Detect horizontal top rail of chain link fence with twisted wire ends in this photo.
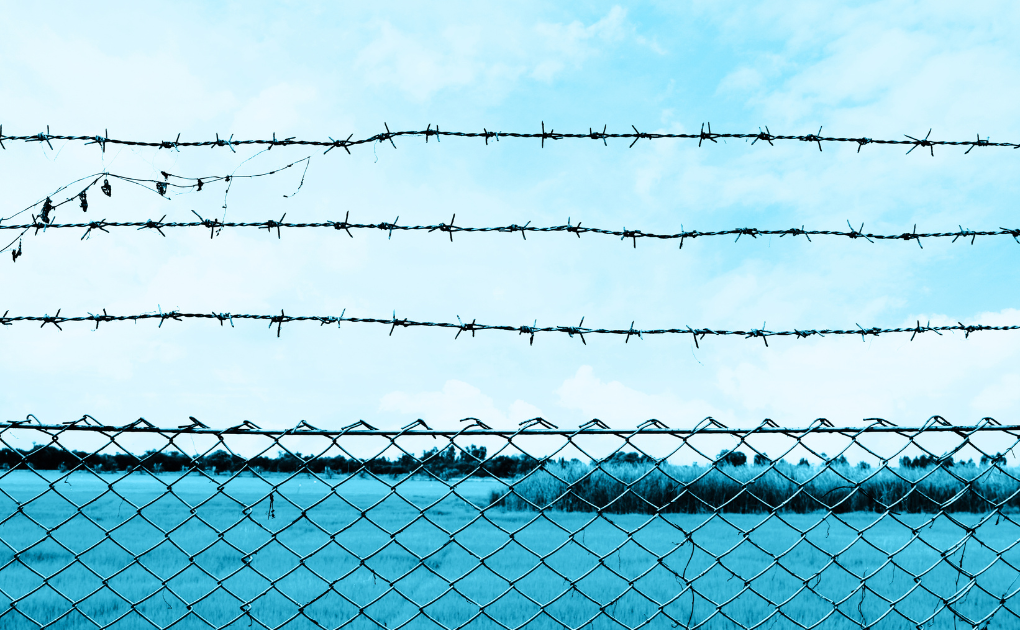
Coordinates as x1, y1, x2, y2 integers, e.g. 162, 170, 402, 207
0, 416, 1020, 438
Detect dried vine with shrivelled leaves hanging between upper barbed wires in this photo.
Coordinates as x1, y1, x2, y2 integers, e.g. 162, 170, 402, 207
0, 158, 311, 255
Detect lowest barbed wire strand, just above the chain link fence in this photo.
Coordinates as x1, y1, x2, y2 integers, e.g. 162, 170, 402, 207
0, 309, 1020, 340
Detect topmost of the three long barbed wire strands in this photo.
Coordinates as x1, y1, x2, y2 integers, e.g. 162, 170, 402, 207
0, 121, 1007, 156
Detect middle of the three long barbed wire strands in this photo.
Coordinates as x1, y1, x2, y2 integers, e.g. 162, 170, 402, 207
0, 210, 1020, 249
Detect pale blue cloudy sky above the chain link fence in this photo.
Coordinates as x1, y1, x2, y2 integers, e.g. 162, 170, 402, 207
0, 1, 1020, 436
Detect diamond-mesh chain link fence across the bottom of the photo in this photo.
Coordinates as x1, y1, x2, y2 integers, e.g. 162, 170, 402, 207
0, 416, 1020, 630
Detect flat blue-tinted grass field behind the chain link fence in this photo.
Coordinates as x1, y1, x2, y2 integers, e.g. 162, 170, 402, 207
0, 471, 1020, 630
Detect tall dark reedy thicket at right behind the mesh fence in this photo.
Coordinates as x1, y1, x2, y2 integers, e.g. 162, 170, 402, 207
490, 457, 1020, 514
